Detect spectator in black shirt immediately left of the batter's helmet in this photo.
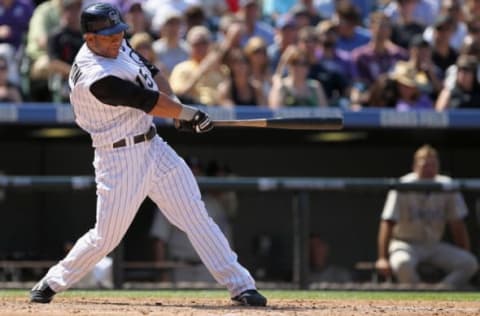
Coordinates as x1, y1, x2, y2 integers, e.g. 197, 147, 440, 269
47, 0, 84, 103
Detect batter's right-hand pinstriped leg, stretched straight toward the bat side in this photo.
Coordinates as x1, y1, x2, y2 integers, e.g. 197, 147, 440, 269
149, 140, 264, 304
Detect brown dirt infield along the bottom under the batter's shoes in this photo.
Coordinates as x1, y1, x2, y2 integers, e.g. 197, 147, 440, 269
0, 297, 480, 316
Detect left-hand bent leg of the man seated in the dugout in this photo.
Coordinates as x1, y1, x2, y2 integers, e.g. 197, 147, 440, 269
389, 240, 420, 284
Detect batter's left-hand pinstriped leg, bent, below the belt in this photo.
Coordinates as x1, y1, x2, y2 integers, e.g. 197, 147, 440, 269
32, 146, 148, 299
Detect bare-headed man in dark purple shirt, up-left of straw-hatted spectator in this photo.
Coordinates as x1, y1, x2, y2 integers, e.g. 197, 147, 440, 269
350, 11, 408, 105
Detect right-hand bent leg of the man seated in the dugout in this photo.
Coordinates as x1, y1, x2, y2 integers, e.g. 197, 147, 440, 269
429, 242, 478, 287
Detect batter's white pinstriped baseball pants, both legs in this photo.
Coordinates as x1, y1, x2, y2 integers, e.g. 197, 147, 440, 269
44, 136, 255, 296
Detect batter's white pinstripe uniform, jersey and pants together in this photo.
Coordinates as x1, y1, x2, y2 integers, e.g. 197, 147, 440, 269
40, 40, 255, 297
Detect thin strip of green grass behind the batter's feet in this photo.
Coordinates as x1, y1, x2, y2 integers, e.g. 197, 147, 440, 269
0, 290, 480, 302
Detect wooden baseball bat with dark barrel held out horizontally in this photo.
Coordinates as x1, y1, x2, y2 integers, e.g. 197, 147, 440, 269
213, 116, 343, 130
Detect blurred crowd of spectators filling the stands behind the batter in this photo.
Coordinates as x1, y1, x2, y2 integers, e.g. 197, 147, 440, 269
0, 0, 480, 111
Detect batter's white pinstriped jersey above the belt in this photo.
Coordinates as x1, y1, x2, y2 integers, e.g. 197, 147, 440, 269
69, 40, 158, 147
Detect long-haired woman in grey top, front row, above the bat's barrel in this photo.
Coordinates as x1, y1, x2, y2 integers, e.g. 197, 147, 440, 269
268, 46, 328, 109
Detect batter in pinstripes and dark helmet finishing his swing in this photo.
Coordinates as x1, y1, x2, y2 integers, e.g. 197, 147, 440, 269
31, 3, 267, 306
